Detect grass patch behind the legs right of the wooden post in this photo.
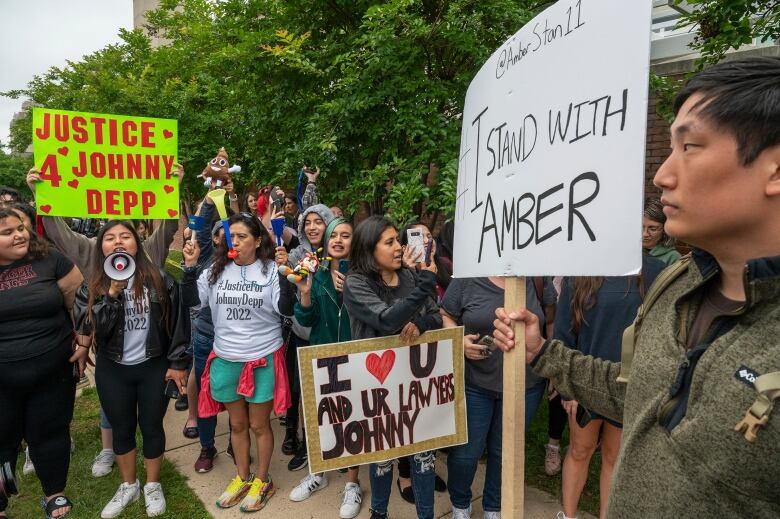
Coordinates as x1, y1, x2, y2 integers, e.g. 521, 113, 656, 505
525, 398, 601, 517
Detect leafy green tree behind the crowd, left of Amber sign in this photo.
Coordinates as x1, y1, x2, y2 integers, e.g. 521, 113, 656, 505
7, 0, 548, 223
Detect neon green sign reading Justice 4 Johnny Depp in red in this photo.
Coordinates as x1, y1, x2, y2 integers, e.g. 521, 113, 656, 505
32, 108, 179, 219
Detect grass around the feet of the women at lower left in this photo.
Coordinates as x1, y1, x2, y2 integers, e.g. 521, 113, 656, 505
7, 389, 211, 519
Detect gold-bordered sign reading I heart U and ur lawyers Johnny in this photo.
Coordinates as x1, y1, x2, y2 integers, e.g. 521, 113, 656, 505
298, 328, 468, 474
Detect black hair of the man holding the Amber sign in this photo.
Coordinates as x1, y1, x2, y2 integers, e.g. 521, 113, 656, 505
674, 57, 780, 166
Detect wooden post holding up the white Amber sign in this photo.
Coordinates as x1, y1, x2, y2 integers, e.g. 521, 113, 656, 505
501, 277, 525, 517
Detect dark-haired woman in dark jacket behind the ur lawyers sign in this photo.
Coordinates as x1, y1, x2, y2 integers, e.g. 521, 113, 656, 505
344, 216, 442, 519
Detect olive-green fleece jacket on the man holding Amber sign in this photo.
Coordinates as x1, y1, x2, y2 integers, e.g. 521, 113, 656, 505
533, 251, 780, 519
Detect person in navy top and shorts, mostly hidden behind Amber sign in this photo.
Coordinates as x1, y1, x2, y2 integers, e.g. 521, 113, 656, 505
553, 254, 664, 519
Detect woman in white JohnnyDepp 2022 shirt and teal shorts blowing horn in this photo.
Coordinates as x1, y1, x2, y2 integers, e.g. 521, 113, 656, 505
184, 213, 293, 512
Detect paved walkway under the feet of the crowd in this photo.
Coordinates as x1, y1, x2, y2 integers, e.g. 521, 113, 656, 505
165, 404, 592, 519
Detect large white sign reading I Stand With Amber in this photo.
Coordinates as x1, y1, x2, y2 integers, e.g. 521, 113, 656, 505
453, 0, 651, 277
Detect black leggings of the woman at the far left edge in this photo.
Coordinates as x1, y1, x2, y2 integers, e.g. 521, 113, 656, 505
0, 339, 76, 511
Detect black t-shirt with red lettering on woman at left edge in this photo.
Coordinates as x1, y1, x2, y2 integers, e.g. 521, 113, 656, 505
0, 250, 73, 362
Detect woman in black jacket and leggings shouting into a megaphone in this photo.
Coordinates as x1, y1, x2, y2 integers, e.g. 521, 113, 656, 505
76, 220, 190, 518
